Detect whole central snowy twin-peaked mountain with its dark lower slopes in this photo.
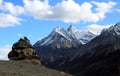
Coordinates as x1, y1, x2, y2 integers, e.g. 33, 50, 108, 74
34, 25, 106, 65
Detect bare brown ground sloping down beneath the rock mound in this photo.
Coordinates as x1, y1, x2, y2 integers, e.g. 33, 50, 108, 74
0, 60, 72, 76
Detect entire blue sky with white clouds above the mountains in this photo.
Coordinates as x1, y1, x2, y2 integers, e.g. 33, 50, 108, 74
0, 0, 120, 47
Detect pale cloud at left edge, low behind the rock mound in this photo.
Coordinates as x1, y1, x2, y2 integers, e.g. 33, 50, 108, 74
0, 45, 11, 60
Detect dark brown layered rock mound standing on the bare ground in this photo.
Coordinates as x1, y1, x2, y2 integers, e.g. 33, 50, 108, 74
8, 37, 38, 60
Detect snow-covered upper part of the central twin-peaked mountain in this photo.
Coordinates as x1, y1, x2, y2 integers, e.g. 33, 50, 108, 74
38, 25, 100, 44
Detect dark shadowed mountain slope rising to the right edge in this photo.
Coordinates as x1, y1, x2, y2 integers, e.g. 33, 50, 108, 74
60, 23, 120, 76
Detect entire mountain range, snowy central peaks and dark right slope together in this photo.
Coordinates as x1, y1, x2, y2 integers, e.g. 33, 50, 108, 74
34, 22, 120, 76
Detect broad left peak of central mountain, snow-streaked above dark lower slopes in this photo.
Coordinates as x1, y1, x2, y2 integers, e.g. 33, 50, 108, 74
36, 27, 80, 48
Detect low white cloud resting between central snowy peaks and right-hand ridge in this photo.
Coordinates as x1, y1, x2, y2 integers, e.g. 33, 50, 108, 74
86, 24, 111, 35
